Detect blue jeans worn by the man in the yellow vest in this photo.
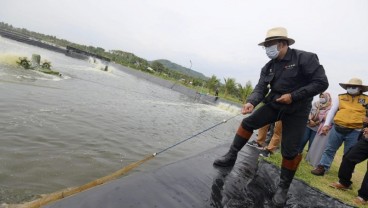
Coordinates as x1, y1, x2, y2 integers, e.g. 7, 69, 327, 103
319, 126, 360, 171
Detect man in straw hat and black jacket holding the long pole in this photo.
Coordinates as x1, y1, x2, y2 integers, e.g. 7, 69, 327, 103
214, 27, 328, 206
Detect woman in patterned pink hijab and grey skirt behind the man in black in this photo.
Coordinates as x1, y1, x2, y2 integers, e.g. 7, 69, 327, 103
301, 92, 332, 167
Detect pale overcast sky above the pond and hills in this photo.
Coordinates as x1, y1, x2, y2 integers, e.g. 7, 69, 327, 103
0, 0, 368, 96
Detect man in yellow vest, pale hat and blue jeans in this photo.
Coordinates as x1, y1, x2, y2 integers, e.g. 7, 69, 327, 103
311, 78, 368, 176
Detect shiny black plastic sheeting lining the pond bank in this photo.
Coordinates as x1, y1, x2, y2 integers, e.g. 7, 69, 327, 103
46, 144, 351, 208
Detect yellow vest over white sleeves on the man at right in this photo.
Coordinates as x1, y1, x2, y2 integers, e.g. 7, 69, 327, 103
334, 94, 368, 129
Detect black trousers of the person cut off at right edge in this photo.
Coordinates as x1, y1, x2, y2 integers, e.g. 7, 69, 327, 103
339, 139, 368, 200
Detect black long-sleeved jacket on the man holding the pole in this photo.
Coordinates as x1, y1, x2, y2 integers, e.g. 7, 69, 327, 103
247, 48, 328, 106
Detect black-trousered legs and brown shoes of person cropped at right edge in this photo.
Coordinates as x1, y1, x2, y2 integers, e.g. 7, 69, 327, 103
330, 126, 368, 205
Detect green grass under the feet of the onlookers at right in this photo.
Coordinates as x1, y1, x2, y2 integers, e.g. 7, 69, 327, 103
265, 146, 368, 208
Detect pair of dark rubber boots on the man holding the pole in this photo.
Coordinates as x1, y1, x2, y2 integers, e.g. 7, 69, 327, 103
213, 136, 296, 207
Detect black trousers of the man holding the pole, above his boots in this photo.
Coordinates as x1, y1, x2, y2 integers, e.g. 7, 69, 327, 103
241, 102, 311, 160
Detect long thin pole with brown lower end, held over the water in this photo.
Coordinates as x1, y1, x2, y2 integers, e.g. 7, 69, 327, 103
11, 113, 241, 208
